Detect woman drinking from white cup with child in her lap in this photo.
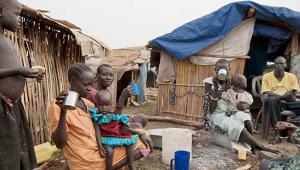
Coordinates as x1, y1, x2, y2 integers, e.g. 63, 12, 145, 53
204, 59, 274, 152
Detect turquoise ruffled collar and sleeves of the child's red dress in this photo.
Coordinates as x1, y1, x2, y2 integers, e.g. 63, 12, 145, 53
88, 108, 129, 125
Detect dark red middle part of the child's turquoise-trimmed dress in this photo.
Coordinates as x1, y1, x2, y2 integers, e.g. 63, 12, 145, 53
99, 120, 132, 138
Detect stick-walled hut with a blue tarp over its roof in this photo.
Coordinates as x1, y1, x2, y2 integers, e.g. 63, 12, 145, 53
147, 1, 300, 119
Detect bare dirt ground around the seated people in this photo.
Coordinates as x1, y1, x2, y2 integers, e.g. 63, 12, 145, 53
45, 101, 297, 170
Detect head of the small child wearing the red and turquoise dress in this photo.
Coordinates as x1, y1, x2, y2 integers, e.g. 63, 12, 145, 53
95, 90, 111, 114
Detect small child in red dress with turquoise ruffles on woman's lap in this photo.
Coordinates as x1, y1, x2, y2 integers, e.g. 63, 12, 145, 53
89, 90, 143, 170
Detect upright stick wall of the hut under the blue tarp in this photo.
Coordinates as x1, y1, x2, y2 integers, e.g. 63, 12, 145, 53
158, 52, 246, 120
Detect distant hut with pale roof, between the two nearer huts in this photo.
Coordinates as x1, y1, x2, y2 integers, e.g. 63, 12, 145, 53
99, 46, 150, 105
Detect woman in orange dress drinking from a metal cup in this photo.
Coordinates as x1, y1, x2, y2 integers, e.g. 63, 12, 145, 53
48, 64, 153, 170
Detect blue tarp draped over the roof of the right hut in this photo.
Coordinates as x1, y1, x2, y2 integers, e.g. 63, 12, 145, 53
149, 1, 300, 60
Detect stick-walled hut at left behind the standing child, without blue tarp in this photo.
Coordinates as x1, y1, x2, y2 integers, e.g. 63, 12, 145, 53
5, 5, 108, 144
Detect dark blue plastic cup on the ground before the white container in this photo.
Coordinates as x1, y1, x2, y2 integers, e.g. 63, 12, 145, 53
170, 151, 190, 170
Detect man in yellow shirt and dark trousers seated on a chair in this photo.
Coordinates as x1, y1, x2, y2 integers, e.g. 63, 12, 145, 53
261, 56, 300, 127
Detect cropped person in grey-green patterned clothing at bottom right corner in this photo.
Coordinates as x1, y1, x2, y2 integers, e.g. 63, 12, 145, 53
259, 128, 300, 170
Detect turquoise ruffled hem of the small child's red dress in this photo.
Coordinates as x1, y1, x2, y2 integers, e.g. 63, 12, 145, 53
101, 135, 139, 147
